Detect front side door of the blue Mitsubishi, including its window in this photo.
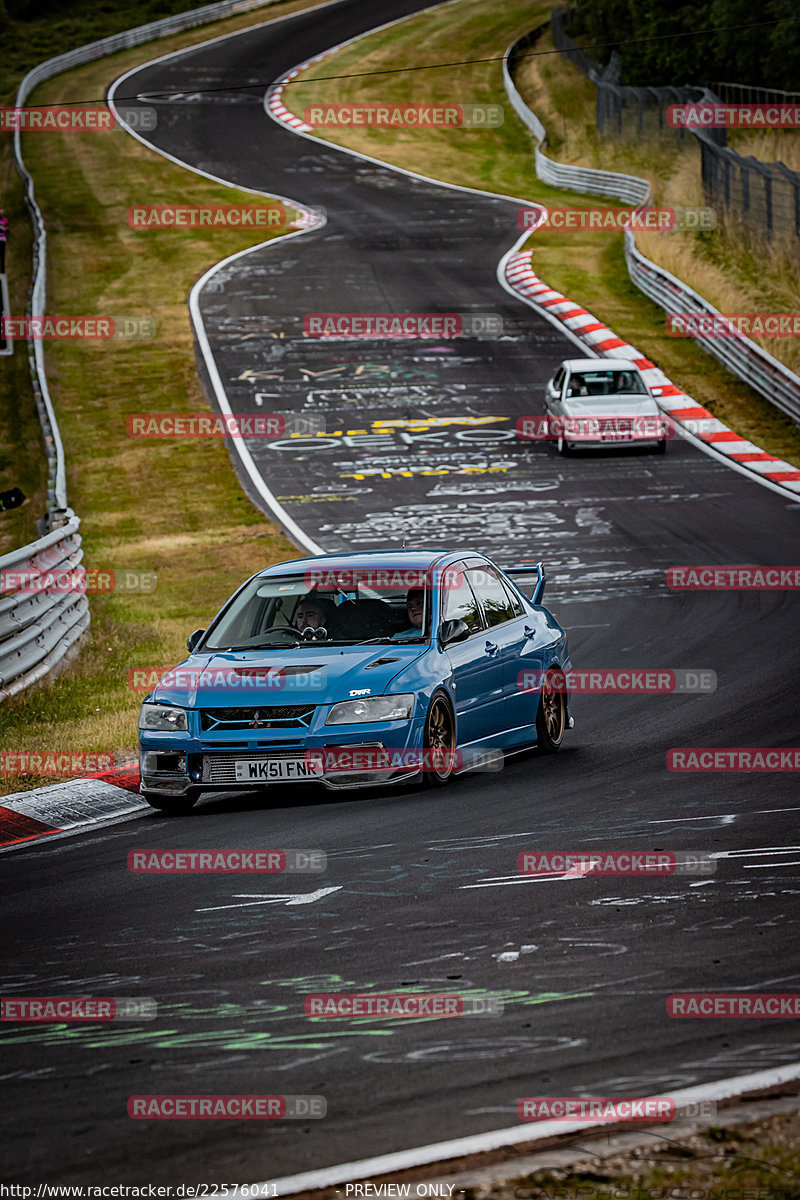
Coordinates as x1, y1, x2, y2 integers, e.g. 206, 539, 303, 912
441, 563, 497, 746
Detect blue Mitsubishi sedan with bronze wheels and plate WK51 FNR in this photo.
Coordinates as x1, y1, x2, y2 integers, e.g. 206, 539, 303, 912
139, 550, 572, 812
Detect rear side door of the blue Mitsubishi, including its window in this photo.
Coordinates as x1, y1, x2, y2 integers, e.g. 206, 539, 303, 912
467, 563, 527, 733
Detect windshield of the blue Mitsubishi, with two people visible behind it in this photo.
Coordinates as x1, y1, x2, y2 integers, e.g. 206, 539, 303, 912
200, 566, 431, 650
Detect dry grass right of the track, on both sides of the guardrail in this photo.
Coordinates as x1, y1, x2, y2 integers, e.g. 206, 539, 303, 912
283, 0, 800, 467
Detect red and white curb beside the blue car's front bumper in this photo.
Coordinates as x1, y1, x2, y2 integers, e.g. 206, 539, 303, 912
0, 766, 149, 850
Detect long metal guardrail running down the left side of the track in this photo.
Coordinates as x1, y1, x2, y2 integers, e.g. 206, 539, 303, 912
0, 0, 284, 701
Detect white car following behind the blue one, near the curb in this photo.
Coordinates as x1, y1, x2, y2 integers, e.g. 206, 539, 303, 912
545, 359, 670, 454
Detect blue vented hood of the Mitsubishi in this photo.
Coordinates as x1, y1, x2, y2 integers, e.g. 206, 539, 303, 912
149, 644, 428, 708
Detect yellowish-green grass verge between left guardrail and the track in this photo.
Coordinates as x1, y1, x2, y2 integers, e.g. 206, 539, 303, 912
0, 2, 326, 793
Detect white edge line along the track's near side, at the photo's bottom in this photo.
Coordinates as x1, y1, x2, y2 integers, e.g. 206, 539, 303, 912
248, 1062, 800, 1195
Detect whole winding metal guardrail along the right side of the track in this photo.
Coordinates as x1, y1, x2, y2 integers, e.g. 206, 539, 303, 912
503, 34, 800, 424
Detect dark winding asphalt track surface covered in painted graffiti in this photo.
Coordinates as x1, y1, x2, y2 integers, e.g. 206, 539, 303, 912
0, 4, 800, 1183
